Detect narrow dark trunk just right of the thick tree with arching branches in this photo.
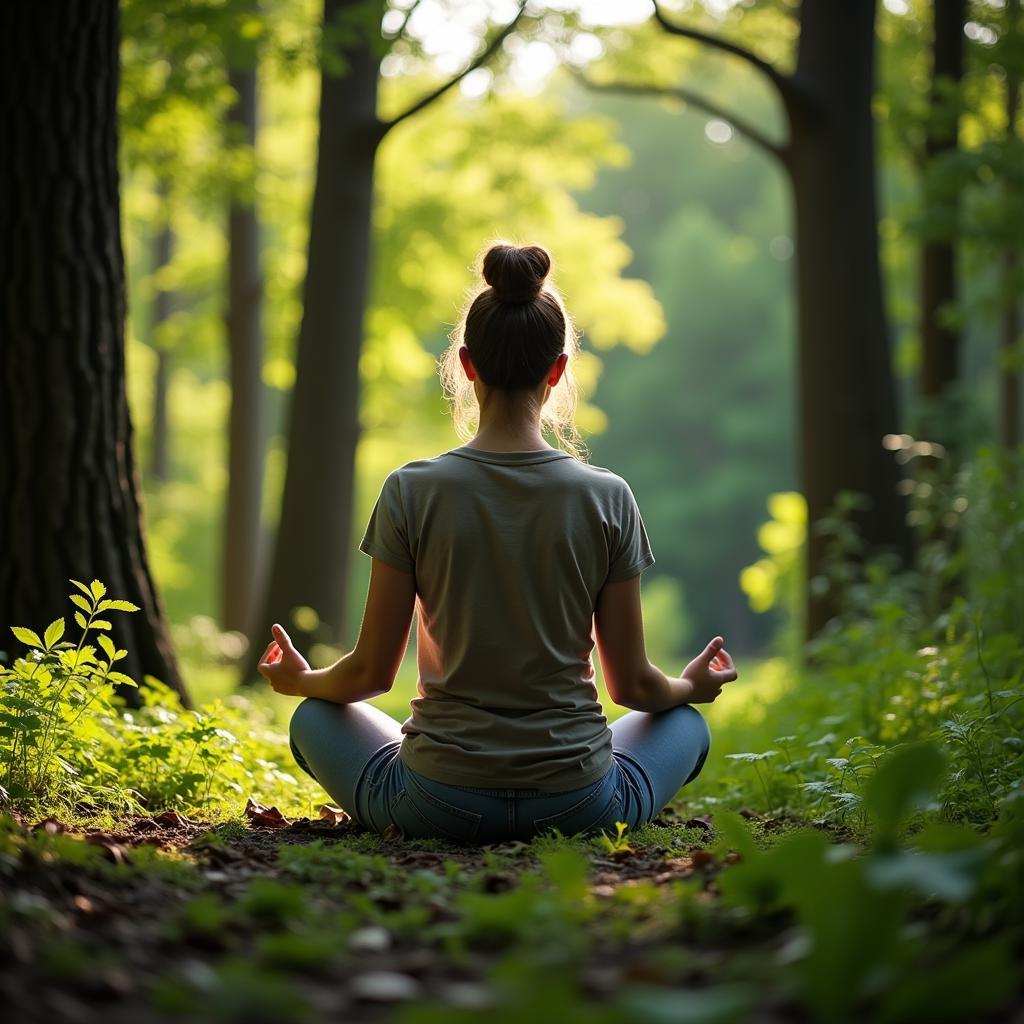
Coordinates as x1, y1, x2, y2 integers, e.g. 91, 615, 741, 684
921, 0, 967, 415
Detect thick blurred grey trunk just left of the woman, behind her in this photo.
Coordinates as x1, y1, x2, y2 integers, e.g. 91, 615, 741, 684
245, 0, 382, 677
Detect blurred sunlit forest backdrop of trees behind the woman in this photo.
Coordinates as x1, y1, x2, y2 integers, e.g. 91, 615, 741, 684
8, 0, 1022, 700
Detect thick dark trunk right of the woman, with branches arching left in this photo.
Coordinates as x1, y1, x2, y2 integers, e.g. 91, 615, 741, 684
787, 0, 911, 636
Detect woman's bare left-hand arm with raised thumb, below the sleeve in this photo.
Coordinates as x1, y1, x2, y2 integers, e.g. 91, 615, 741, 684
259, 558, 416, 703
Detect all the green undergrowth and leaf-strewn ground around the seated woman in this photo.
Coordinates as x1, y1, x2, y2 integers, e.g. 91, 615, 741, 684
0, 459, 1024, 1024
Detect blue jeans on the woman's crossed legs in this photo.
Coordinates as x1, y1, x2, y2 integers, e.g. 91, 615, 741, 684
291, 699, 711, 844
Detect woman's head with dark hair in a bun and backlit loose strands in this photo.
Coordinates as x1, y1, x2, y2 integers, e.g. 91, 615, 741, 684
440, 243, 586, 457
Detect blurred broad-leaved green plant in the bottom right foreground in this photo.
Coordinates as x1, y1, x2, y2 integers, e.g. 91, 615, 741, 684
716, 798, 1016, 1022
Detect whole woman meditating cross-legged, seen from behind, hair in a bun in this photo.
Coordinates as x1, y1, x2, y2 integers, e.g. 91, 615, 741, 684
259, 245, 736, 844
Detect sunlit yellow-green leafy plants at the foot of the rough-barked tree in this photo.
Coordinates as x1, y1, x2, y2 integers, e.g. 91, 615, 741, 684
0, 580, 315, 813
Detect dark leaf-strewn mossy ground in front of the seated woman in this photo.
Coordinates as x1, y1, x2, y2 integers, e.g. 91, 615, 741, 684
0, 806, 803, 1024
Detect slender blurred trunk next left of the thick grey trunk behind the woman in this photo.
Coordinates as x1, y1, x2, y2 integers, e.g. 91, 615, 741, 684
221, 68, 265, 632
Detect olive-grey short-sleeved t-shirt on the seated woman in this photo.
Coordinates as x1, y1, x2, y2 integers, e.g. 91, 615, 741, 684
359, 446, 654, 793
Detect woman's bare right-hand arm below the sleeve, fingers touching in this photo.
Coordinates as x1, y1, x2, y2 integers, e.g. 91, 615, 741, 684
594, 574, 736, 712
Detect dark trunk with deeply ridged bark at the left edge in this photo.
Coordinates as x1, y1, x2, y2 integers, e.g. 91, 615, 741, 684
0, 0, 183, 695
